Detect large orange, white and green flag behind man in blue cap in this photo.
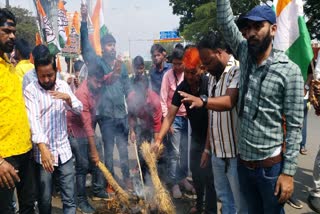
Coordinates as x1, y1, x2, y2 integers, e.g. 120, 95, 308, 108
273, 0, 313, 80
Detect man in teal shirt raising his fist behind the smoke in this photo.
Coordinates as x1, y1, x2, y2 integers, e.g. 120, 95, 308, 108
81, 5, 132, 189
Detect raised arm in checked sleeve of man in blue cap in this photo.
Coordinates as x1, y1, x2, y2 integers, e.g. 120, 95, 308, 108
217, 0, 246, 59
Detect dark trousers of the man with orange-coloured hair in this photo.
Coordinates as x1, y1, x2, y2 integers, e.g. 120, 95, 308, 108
190, 138, 217, 214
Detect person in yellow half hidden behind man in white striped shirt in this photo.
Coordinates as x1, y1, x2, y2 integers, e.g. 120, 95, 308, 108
14, 39, 34, 82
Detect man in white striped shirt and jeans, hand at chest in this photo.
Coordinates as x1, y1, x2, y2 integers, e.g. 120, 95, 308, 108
24, 45, 82, 214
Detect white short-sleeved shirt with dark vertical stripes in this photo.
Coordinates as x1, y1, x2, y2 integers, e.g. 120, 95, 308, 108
208, 56, 240, 158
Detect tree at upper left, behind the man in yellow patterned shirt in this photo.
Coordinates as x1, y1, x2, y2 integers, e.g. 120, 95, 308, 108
9, 7, 38, 47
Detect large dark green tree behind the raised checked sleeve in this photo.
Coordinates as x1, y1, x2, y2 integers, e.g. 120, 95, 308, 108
170, 0, 267, 41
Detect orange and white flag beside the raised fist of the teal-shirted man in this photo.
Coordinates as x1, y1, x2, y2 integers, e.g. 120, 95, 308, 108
90, 0, 108, 56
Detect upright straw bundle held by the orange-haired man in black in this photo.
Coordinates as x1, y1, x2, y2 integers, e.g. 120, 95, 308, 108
140, 142, 176, 214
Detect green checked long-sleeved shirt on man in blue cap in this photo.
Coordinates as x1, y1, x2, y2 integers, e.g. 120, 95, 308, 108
217, 0, 304, 175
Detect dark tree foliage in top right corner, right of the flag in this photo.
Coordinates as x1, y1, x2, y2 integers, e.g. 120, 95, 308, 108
304, 0, 320, 40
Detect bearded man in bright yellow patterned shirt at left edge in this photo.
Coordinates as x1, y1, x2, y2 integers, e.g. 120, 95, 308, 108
0, 9, 35, 214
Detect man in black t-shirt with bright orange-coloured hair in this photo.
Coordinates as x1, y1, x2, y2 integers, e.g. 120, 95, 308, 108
153, 48, 217, 213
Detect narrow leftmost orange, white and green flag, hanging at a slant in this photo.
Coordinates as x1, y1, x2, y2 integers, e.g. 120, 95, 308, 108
36, 0, 60, 55
